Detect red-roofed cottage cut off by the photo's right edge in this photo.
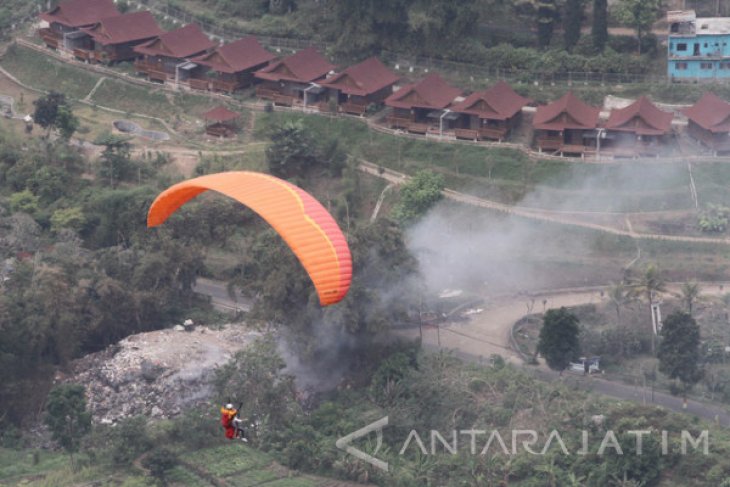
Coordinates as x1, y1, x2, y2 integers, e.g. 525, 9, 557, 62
682, 93, 730, 155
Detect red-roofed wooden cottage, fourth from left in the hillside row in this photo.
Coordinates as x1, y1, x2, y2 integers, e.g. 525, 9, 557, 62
190, 36, 276, 93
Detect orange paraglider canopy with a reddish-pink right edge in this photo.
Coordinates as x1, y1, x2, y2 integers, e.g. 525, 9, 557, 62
147, 171, 352, 306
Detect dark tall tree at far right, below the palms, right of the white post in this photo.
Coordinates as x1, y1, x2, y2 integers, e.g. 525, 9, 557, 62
657, 311, 704, 396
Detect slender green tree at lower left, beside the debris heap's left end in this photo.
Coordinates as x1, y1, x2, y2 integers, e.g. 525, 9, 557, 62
44, 384, 91, 468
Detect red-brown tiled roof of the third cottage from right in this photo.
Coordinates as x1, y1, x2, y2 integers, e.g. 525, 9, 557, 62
532, 92, 601, 131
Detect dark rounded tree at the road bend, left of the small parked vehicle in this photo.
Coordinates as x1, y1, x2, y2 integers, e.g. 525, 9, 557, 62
537, 307, 580, 371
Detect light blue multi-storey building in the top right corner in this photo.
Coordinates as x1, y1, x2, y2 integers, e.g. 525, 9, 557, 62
667, 10, 730, 81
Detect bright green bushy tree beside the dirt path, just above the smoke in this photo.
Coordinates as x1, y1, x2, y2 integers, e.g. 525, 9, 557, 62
393, 170, 445, 224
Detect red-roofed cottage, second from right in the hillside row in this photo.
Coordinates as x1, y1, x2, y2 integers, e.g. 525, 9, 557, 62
598, 96, 674, 157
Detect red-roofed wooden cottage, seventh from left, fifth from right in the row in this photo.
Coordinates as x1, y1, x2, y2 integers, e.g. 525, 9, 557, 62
385, 73, 462, 135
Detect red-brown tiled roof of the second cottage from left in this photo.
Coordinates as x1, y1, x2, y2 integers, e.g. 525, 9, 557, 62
82, 10, 165, 45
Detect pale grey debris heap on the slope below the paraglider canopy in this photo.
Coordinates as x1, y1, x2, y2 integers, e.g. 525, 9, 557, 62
57, 323, 258, 424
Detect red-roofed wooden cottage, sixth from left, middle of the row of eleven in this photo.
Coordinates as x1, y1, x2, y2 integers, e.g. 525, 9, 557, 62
321, 57, 400, 115
